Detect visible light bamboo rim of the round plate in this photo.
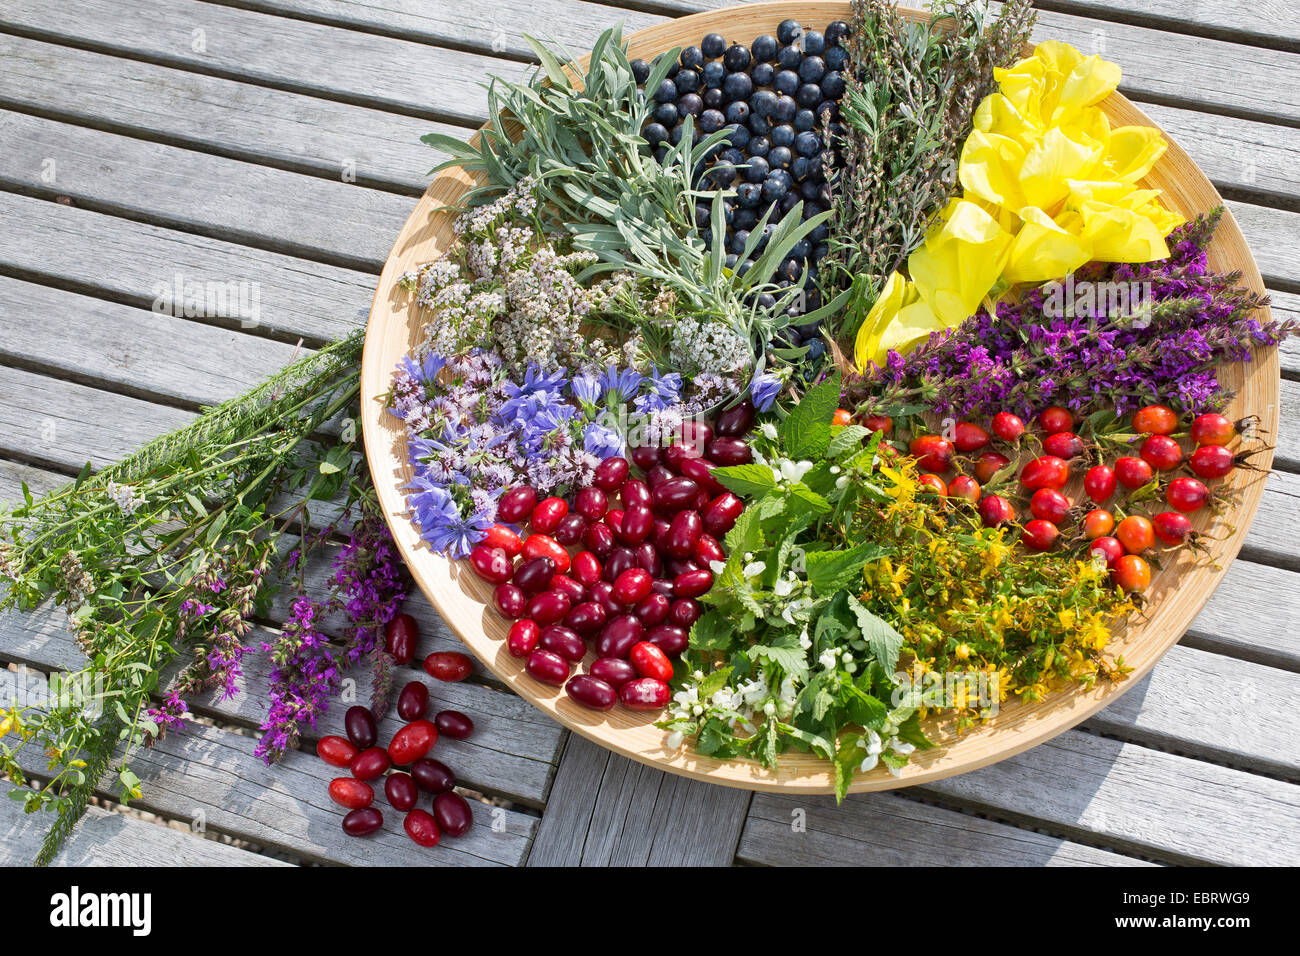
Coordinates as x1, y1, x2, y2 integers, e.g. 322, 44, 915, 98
361, 0, 1279, 793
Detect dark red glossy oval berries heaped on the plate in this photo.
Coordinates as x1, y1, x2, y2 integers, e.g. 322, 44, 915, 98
469, 402, 754, 710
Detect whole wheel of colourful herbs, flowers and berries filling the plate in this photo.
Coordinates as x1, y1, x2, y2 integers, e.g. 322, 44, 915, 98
387, 0, 1294, 796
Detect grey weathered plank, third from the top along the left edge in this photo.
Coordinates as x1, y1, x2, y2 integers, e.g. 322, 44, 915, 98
0, 111, 411, 272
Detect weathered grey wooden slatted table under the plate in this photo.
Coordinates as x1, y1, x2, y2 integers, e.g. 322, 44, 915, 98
0, 0, 1300, 866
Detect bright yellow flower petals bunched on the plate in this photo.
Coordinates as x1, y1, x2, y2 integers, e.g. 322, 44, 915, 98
854, 40, 1183, 368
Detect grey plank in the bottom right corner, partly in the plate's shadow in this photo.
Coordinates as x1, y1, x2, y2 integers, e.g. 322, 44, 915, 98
917, 731, 1300, 866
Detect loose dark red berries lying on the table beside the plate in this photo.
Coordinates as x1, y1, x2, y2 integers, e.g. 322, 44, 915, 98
316, 614, 475, 847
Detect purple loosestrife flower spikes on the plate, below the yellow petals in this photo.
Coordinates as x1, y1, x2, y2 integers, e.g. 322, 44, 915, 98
849, 213, 1296, 418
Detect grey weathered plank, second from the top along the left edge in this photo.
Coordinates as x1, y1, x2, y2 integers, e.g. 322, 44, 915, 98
0, 34, 452, 194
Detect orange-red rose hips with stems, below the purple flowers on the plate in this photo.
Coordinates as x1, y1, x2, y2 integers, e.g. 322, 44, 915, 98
889, 405, 1243, 592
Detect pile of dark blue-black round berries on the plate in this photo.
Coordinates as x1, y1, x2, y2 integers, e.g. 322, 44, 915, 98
632, 20, 849, 358
